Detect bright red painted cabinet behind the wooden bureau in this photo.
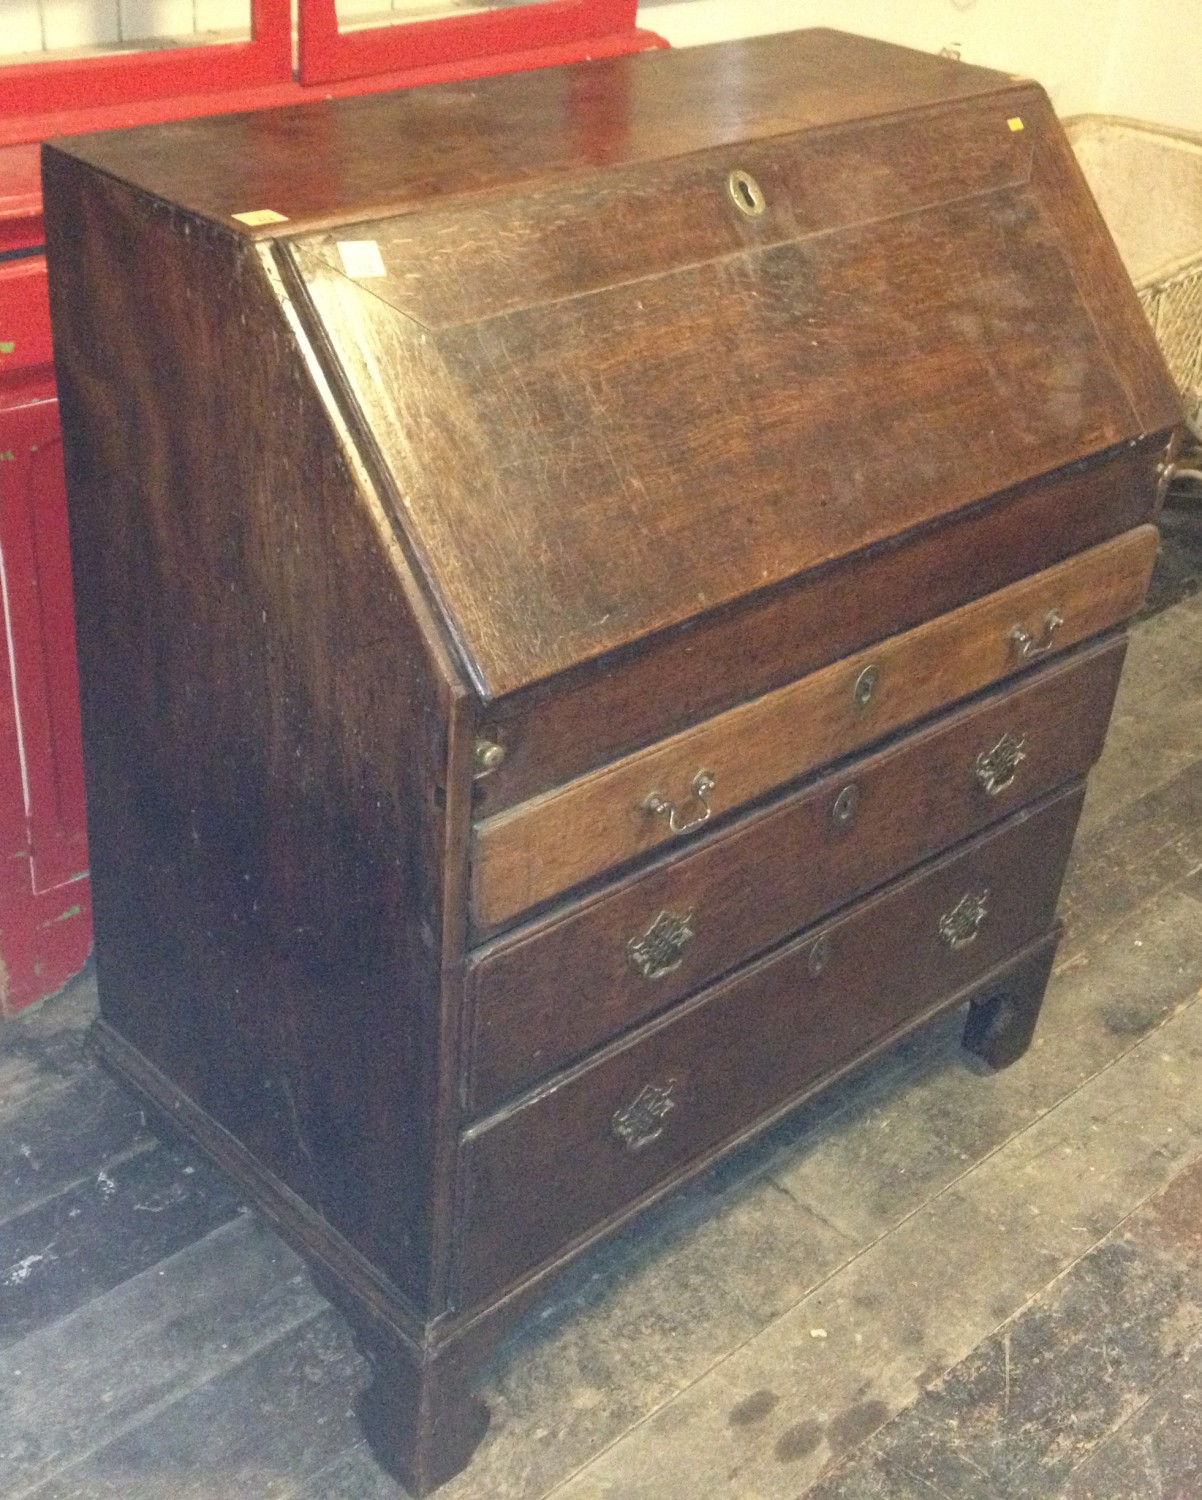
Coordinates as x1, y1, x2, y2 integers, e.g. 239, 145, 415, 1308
0, 0, 665, 1016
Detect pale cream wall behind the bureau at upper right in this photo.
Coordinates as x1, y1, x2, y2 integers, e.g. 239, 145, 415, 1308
639, 0, 1202, 131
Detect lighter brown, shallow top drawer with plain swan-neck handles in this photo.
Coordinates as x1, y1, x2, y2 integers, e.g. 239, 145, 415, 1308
471, 527, 1155, 932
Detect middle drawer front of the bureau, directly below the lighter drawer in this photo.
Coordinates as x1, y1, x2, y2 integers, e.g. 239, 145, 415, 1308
464, 639, 1125, 1113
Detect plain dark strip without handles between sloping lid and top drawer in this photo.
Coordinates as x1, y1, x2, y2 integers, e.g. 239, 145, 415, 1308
476, 432, 1167, 818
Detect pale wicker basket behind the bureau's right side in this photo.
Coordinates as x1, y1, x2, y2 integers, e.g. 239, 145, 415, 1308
1065, 114, 1202, 438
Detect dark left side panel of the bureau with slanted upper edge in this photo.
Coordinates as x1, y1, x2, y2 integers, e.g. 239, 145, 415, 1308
47, 150, 462, 1308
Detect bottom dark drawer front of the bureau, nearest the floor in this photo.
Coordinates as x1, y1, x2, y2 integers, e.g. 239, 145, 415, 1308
458, 785, 1083, 1305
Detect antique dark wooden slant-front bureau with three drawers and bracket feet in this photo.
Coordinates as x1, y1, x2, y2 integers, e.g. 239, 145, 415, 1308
45, 32, 1178, 1493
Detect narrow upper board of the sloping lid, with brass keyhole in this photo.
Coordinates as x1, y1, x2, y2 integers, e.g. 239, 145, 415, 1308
290, 98, 1032, 332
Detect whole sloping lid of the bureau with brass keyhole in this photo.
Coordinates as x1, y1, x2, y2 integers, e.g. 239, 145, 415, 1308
284, 98, 1133, 698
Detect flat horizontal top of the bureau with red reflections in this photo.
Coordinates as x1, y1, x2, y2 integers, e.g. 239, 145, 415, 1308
46, 30, 1029, 239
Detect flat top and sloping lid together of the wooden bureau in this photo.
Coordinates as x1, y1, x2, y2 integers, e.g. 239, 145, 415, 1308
56, 30, 1178, 699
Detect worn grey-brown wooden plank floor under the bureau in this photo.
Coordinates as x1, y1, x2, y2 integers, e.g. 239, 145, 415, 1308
0, 510, 1202, 1500
